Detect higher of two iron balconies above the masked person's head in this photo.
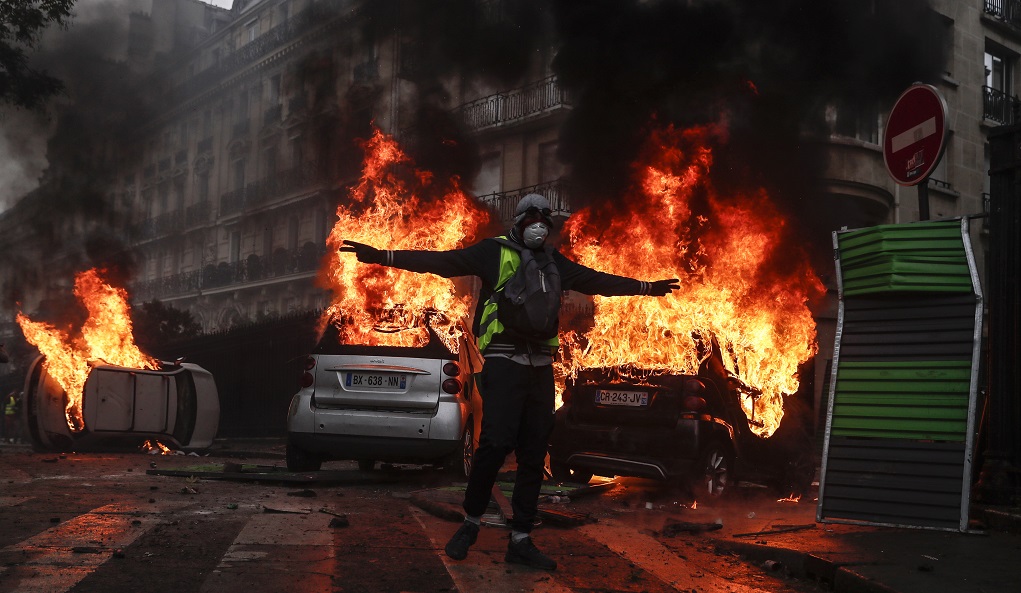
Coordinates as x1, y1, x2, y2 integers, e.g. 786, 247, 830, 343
457, 77, 571, 132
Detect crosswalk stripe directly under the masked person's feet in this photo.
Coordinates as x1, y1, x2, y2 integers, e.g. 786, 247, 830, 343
411, 507, 573, 593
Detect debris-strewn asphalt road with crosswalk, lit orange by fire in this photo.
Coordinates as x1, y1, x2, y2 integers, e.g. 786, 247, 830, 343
0, 447, 825, 593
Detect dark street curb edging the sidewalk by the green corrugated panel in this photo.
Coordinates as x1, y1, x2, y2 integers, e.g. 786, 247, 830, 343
714, 540, 900, 593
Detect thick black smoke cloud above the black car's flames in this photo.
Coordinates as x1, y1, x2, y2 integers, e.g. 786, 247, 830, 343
553, 0, 946, 260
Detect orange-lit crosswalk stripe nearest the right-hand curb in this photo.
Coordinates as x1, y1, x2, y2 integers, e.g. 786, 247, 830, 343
579, 518, 770, 593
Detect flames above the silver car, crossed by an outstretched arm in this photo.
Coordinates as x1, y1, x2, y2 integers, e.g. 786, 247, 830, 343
321, 130, 489, 352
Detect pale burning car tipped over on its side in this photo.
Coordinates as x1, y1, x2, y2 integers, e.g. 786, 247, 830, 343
22, 356, 220, 451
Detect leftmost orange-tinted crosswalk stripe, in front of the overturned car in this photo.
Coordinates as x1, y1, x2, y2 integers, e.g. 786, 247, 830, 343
0, 504, 179, 593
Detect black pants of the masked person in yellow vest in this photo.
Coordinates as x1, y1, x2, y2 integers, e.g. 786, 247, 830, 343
465, 358, 556, 533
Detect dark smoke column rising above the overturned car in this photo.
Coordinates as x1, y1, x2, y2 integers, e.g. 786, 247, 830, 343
5, 0, 166, 306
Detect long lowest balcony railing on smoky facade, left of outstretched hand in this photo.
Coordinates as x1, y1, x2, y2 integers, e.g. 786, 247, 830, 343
132, 242, 326, 301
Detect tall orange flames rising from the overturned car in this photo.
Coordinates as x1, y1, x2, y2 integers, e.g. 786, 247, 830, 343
16, 268, 159, 432
